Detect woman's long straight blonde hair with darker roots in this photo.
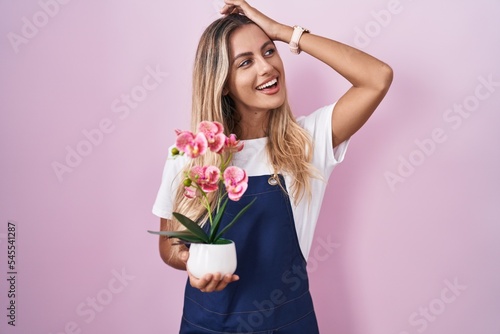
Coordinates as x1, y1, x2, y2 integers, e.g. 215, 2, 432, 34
174, 14, 318, 227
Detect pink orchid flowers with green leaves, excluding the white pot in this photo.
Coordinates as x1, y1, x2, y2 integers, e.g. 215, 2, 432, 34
148, 121, 255, 244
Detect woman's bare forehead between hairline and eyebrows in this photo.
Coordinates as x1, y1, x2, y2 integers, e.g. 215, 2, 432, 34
229, 24, 270, 57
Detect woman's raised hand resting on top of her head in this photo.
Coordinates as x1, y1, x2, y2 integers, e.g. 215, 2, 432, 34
220, 0, 288, 42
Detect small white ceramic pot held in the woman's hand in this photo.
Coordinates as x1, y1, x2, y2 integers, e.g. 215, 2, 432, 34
187, 242, 236, 278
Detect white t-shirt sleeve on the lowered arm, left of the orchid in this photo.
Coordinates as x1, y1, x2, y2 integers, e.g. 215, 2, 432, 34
153, 150, 187, 219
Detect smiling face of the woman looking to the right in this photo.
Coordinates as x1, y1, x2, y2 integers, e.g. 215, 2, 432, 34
226, 24, 286, 117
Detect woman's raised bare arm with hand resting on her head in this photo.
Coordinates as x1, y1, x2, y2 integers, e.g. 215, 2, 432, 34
221, 0, 393, 147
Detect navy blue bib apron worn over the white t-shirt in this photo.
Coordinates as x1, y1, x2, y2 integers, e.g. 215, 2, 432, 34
180, 175, 319, 334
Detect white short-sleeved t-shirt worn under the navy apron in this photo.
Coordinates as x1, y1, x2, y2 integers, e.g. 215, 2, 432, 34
153, 104, 349, 259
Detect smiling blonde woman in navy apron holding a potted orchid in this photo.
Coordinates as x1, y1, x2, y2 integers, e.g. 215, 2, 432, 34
153, 0, 392, 334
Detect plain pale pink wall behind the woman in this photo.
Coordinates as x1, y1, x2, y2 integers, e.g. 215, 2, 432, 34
0, 0, 500, 334
